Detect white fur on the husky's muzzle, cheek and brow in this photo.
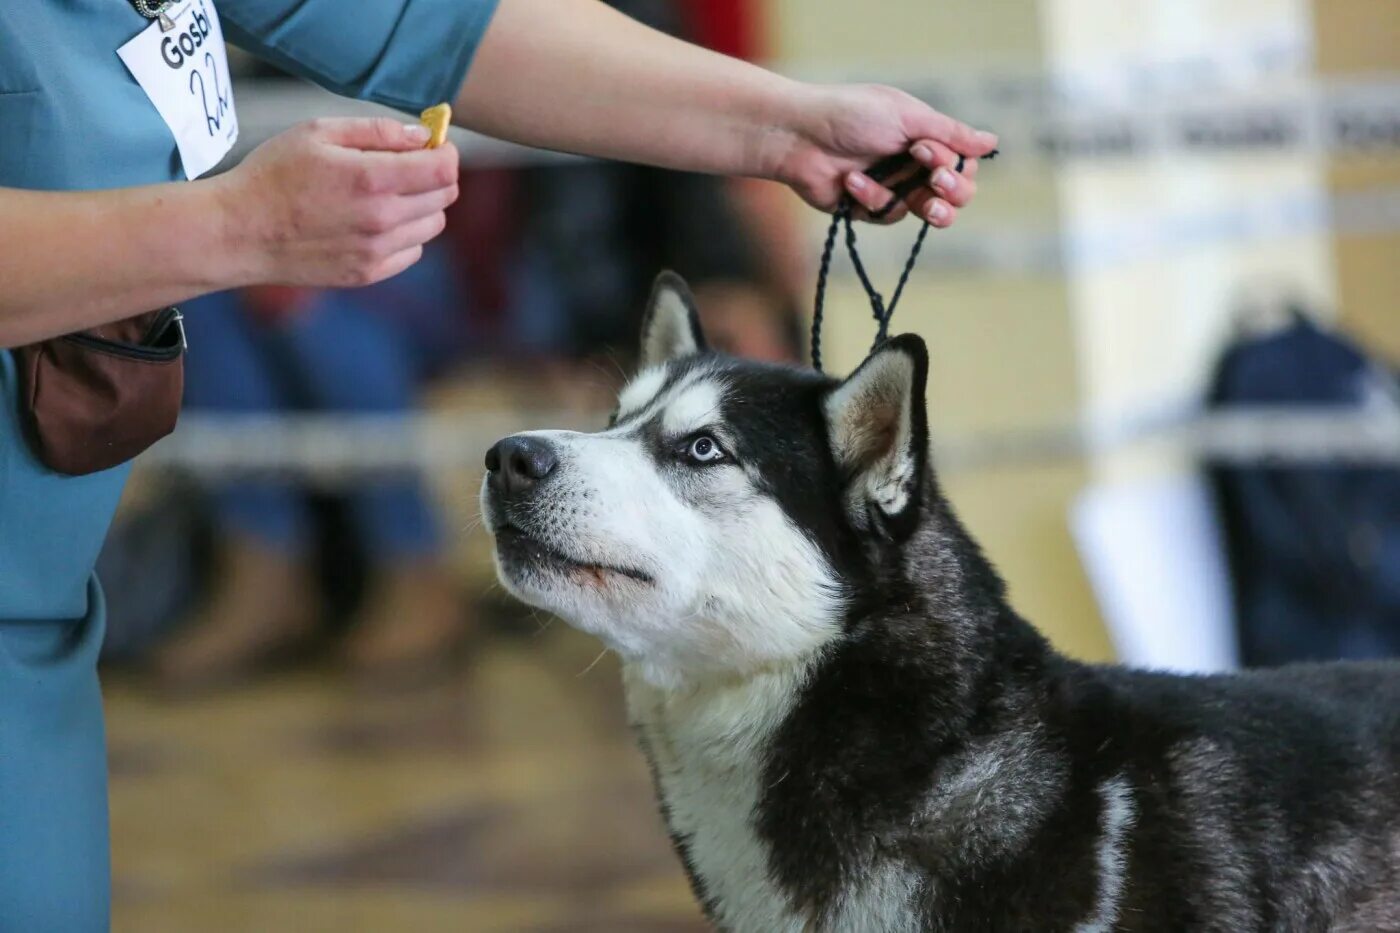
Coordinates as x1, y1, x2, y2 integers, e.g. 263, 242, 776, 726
482, 358, 843, 686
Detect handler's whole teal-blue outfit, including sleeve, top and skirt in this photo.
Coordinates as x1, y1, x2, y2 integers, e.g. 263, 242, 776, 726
0, 0, 494, 933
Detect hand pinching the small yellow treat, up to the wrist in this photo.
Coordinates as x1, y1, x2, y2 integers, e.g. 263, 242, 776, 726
211, 118, 459, 287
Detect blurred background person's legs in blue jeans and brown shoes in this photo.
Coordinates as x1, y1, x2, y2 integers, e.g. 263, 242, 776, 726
155, 248, 469, 686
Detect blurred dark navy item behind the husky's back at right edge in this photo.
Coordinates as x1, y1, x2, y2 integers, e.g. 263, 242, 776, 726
1210, 315, 1400, 665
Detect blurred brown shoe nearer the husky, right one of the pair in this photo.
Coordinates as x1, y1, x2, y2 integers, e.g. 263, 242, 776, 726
342, 559, 472, 686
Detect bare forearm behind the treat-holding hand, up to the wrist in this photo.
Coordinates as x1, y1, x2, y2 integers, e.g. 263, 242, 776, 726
0, 181, 246, 346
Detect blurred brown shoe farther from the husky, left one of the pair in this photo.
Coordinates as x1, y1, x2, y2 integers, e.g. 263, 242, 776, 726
153, 535, 316, 691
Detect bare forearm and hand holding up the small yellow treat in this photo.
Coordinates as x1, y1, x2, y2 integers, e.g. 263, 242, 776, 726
0, 118, 461, 346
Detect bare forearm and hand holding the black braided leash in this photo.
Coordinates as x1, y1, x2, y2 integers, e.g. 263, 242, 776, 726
456, 0, 997, 227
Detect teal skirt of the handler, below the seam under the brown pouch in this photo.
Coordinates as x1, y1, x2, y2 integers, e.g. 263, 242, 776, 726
0, 581, 111, 933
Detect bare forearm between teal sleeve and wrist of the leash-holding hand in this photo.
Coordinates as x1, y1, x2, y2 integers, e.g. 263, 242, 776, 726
455, 0, 804, 177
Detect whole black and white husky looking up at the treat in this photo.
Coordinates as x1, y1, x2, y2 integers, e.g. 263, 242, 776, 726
482, 275, 1400, 933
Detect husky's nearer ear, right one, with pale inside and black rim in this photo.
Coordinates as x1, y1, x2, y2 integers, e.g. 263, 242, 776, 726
825, 333, 928, 537
